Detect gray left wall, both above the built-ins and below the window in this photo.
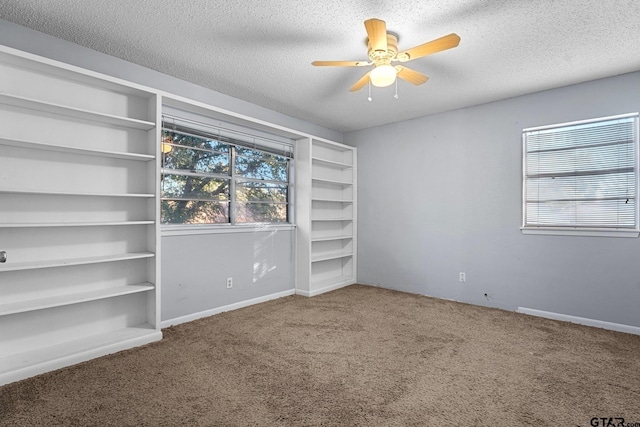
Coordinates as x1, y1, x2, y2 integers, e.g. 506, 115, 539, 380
0, 20, 342, 321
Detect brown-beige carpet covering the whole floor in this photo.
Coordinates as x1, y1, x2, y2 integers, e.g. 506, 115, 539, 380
0, 285, 640, 427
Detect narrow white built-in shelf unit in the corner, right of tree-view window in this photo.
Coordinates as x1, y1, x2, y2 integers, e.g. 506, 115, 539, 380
296, 138, 357, 296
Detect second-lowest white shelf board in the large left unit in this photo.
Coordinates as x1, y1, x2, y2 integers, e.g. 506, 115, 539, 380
0, 283, 154, 316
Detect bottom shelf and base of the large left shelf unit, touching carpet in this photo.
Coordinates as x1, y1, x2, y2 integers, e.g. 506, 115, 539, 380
0, 324, 162, 385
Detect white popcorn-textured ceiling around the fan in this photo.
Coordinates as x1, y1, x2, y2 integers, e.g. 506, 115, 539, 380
0, 0, 640, 132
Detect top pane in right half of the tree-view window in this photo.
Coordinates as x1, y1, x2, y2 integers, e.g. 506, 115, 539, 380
236, 147, 288, 182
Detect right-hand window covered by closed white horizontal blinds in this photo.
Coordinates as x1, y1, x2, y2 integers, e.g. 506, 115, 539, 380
523, 113, 638, 236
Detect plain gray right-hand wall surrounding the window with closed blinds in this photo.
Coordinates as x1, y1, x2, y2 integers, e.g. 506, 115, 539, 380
345, 73, 640, 326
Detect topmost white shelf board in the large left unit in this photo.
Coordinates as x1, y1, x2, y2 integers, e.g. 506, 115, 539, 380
0, 92, 155, 130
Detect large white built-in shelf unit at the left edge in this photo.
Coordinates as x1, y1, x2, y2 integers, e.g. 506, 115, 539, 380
0, 47, 162, 384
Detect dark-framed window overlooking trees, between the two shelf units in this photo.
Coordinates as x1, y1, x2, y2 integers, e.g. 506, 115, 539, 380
161, 118, 292, 224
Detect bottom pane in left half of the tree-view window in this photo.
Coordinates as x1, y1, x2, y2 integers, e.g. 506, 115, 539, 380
162, 199, 229, 224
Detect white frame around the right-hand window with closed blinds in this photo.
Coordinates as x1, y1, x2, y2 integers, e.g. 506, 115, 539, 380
521, 113, 640, 237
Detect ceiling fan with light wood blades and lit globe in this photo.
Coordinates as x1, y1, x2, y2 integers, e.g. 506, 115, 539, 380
311, 18, 460, 92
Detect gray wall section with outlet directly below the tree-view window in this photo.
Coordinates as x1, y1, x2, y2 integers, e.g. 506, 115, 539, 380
161, 229, 295, 321
